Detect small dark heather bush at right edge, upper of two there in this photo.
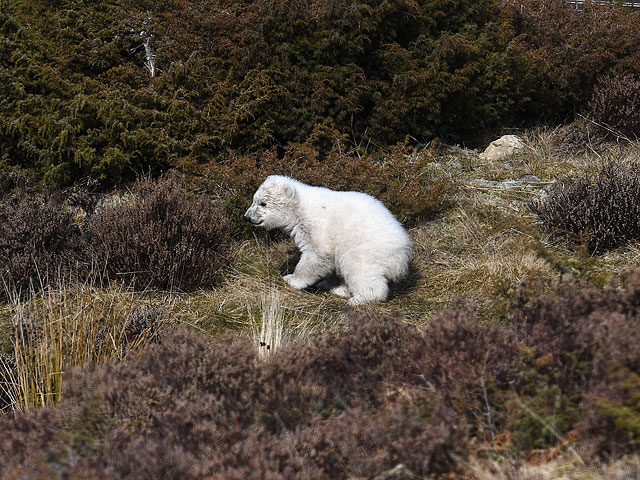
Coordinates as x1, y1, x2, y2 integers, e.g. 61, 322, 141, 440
591, 75, 640, 138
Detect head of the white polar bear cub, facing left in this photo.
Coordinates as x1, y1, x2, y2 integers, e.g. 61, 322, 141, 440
244, 175, 296, 230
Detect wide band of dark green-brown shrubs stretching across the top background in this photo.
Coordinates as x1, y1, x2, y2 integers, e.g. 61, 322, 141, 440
0, 0, 640, 185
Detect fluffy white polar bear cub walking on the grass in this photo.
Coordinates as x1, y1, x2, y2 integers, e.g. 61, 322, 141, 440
244, 175, 412, 305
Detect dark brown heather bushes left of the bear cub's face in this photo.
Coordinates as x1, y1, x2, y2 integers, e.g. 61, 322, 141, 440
0, 178, 230, 296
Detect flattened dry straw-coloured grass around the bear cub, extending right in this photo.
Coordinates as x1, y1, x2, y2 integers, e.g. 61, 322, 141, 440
169, 129, 640, 332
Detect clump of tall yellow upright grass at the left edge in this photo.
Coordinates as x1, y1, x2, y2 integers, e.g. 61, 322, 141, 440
0, 283, 169, 410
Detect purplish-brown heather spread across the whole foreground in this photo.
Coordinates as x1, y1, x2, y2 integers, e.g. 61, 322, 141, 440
0, 272, 640, 479
